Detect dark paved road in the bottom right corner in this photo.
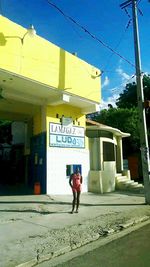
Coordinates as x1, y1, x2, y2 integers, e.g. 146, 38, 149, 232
42, 224, 150, 267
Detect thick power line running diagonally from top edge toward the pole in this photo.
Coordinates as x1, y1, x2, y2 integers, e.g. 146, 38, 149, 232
47, 0, 135, 68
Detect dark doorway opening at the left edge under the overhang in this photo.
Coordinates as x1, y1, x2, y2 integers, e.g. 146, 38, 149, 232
0, 121, 32, 195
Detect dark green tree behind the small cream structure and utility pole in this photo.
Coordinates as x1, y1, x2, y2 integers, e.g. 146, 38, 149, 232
93, 75, 150, 154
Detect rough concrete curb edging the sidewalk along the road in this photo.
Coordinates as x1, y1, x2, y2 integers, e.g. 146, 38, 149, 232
16, 216, 150, 267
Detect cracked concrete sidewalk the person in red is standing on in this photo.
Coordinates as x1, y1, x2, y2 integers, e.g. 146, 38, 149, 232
0, 192, 150, 267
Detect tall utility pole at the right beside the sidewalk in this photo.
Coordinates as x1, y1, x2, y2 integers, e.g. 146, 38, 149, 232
120, 0, 150, 204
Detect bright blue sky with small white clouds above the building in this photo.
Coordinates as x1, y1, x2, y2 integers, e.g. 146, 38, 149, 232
0, 0, 150, 107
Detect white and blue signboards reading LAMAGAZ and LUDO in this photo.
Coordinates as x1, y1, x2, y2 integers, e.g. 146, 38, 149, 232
50, 123, 85, 148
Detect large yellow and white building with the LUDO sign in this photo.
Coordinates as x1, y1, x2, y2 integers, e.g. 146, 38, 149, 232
0, 16, 101, 194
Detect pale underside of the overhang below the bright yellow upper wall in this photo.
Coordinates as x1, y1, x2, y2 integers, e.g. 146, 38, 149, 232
0, 69, 99, 114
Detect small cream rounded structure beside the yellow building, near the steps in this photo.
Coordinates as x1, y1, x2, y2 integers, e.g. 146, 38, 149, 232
86, 119, 130, 193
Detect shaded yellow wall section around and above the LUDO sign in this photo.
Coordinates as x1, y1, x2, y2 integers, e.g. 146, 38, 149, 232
46, 105, 88, 148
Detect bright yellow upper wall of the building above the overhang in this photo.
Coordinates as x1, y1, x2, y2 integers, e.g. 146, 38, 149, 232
0, 16, 101, 103
